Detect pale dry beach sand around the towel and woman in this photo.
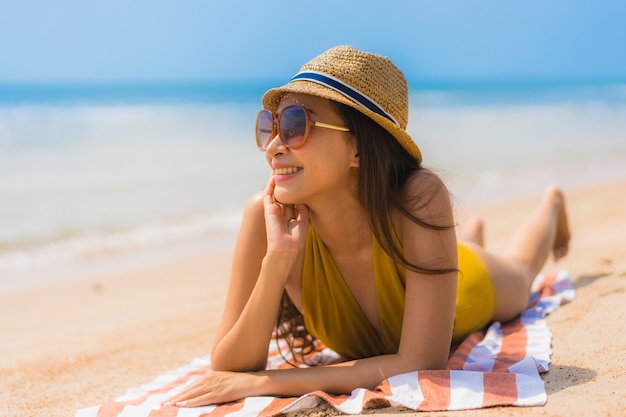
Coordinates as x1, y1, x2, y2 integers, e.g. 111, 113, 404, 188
0, 179, 626, 417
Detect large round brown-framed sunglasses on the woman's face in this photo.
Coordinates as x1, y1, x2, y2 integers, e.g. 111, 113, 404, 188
256, 106, 350, 151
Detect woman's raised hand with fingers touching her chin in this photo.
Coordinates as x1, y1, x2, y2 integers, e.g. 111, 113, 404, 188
263, 176, 309, 254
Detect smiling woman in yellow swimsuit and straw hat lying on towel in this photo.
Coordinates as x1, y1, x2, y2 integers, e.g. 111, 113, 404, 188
163, 46, 570, 407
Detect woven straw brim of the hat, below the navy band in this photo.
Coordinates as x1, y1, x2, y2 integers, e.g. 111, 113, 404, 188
262, 80, 422, 163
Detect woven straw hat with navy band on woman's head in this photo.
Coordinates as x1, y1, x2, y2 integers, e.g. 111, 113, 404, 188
262, 45, 422, 163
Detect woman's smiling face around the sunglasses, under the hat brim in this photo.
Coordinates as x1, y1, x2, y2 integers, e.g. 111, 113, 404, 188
265, 94, 359, 205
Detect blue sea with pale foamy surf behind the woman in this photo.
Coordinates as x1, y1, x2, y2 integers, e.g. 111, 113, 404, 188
0, 81, 626, 292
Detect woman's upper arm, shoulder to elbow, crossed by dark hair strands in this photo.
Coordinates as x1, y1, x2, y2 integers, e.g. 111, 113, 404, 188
396, 171, 458, 370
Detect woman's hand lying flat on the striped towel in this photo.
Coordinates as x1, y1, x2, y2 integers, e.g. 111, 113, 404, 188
163, 369, 259, 407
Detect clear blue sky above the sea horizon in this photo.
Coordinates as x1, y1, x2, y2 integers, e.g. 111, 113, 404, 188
0, 0, 626, 83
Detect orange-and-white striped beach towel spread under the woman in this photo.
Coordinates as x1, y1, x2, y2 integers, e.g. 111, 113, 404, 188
76, 271, 575, 417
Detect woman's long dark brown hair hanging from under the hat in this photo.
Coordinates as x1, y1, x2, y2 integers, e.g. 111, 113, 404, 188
275, 101, 458, 363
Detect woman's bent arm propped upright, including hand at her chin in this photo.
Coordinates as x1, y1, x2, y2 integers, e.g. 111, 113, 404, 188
211, 180, 308, 371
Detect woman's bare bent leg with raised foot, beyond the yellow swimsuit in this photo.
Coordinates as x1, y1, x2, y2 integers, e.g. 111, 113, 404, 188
460, 187, 570, 321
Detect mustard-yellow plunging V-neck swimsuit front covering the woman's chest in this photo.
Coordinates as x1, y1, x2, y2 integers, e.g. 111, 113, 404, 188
302, 225, 406, 359
